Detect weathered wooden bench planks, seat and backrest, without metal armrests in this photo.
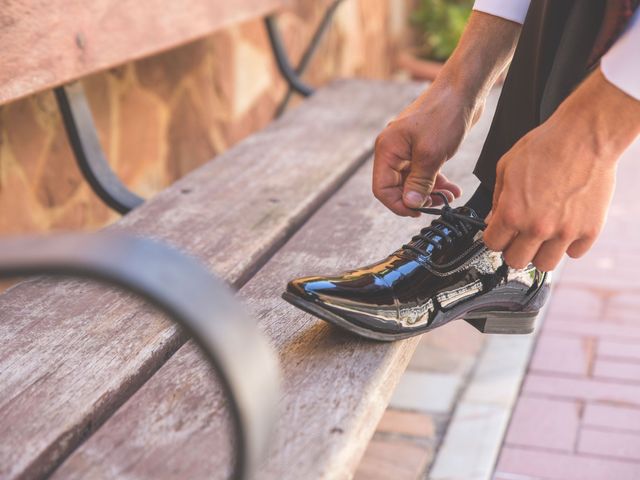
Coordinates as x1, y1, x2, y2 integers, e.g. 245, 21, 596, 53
0, 0, 472, 479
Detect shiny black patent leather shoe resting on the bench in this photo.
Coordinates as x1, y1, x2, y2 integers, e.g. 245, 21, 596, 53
282, 191, 550, 341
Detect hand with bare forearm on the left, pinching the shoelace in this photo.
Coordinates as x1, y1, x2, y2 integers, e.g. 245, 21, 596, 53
373, 12, 521, 216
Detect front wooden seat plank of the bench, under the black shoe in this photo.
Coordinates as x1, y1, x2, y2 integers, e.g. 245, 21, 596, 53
54, 89, 496, 480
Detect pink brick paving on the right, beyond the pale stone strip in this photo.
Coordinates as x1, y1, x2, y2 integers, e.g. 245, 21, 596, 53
494, 139, 640, 480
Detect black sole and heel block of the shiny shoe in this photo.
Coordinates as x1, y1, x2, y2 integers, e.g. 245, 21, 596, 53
282, 292, 538, 342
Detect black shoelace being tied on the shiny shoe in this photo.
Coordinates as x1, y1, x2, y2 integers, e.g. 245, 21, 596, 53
402, 192, 487, 255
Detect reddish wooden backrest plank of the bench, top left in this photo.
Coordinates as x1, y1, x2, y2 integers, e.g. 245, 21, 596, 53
0, 0, 295, 104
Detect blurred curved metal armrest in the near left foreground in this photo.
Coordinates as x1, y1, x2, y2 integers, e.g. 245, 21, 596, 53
0, 233, 279, 479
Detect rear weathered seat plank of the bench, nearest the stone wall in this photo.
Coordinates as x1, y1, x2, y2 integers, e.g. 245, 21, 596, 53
0, 81, 421, 478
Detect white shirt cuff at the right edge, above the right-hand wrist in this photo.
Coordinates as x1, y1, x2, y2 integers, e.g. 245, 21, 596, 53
600, 8, 640, 100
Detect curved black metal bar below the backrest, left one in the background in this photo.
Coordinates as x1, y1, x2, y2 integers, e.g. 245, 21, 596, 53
55, 82, 144, 214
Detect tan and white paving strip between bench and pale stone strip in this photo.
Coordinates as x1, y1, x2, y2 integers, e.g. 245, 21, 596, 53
355, 322, 485, 480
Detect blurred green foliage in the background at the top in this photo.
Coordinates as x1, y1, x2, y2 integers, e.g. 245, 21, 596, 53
411, 0, 473, 60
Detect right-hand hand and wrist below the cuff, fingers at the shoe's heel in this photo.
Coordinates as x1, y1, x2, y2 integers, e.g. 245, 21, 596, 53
484, 70, 640, 271
